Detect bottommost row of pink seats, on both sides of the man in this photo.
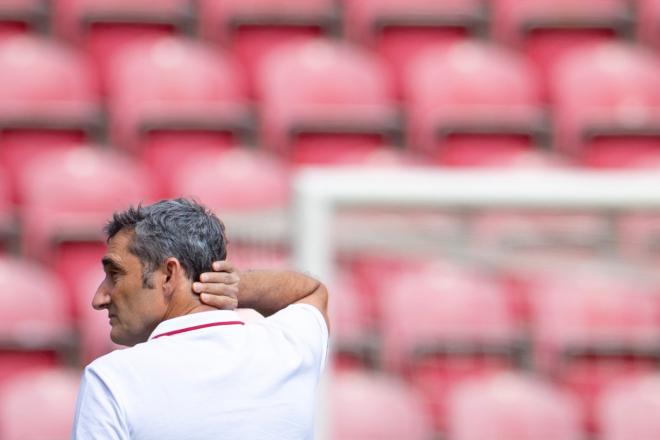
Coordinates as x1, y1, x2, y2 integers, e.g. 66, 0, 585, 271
0, 368, 660, 440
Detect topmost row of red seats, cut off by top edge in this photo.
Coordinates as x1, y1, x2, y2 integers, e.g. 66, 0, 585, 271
0, 0, 660, 94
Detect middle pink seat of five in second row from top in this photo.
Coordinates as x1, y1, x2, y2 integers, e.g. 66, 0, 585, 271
257, 40, 400, 164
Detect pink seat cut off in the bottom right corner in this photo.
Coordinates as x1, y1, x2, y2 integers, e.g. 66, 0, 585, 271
598, 372, 660, 440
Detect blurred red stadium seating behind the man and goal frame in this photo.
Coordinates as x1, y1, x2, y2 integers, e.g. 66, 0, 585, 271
0, 0, 660, 440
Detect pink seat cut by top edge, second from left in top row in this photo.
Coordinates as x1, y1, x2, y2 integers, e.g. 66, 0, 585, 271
54, 0, 195, 91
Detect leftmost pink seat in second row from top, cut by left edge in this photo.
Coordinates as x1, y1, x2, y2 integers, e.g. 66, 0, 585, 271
0, 36, 101, 203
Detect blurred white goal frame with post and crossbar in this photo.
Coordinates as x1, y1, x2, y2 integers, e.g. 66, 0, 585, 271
291, 167, 660, 440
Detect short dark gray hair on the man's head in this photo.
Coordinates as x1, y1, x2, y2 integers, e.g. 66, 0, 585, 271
104, 198, 227, 287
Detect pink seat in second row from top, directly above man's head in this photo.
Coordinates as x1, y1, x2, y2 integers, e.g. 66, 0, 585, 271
109, 38, 252, 196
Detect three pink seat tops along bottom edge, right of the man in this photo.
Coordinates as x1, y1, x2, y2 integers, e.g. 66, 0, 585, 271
330, 373, 660, 440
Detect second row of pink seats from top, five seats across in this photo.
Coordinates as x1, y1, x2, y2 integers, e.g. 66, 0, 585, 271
0, 37, 660, 201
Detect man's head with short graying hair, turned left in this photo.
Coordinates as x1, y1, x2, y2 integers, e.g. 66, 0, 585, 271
92, 199, 226, 345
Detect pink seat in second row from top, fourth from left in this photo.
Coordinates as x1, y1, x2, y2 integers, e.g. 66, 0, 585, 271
404, 41, 548, 166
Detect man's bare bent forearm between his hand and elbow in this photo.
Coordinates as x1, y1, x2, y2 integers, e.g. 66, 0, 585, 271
238, 270, 325, 316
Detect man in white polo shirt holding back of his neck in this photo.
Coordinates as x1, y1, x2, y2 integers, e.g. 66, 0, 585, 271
73, 199, 328, 440
